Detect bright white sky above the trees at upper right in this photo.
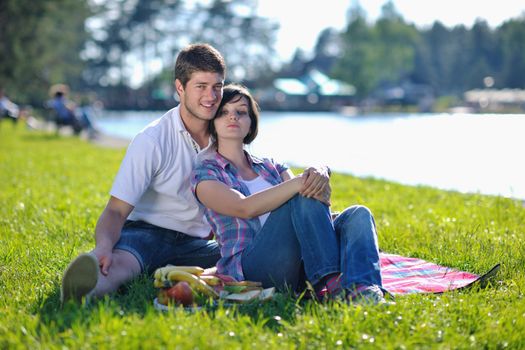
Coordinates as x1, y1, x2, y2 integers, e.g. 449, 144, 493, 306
258, 0, 525, 61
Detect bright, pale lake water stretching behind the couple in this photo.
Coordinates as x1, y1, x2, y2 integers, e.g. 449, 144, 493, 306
97, 112, 525, 199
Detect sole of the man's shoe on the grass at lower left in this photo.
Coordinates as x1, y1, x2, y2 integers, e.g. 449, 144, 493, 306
60, 253, 99, 305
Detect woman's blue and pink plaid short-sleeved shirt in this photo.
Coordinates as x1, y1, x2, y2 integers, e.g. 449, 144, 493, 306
191, 152, 288, 281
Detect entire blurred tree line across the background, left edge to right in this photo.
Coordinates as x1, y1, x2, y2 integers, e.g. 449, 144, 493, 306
0, 0, 525, 106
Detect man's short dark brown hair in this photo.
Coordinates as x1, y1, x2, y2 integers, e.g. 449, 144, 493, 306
175, 43, 226, 87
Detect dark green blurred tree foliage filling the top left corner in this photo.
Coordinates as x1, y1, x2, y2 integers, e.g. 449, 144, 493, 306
0, 0, 90, 107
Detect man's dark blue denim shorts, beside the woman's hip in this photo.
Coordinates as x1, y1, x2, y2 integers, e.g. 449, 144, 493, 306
113, 220, 221, 273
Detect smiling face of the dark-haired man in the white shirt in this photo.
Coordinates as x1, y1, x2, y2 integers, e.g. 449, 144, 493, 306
175, 72, 224, 121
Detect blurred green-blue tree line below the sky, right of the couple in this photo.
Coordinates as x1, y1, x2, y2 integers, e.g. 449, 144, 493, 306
332, 2, 525, 97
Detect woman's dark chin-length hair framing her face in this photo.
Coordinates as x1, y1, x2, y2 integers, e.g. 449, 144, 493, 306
208, 84, 260, 145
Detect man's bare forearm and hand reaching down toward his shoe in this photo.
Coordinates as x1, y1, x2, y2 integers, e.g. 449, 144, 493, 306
94, 196, 133, 275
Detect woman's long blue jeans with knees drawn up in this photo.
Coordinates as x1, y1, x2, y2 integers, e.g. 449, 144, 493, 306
242, 195, 381, 289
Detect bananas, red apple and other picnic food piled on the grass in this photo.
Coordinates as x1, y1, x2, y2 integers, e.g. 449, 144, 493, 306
153, 265, 274, 306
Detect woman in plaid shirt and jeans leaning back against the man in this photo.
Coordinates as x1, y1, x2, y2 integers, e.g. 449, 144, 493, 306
192, 85, 384, 303
